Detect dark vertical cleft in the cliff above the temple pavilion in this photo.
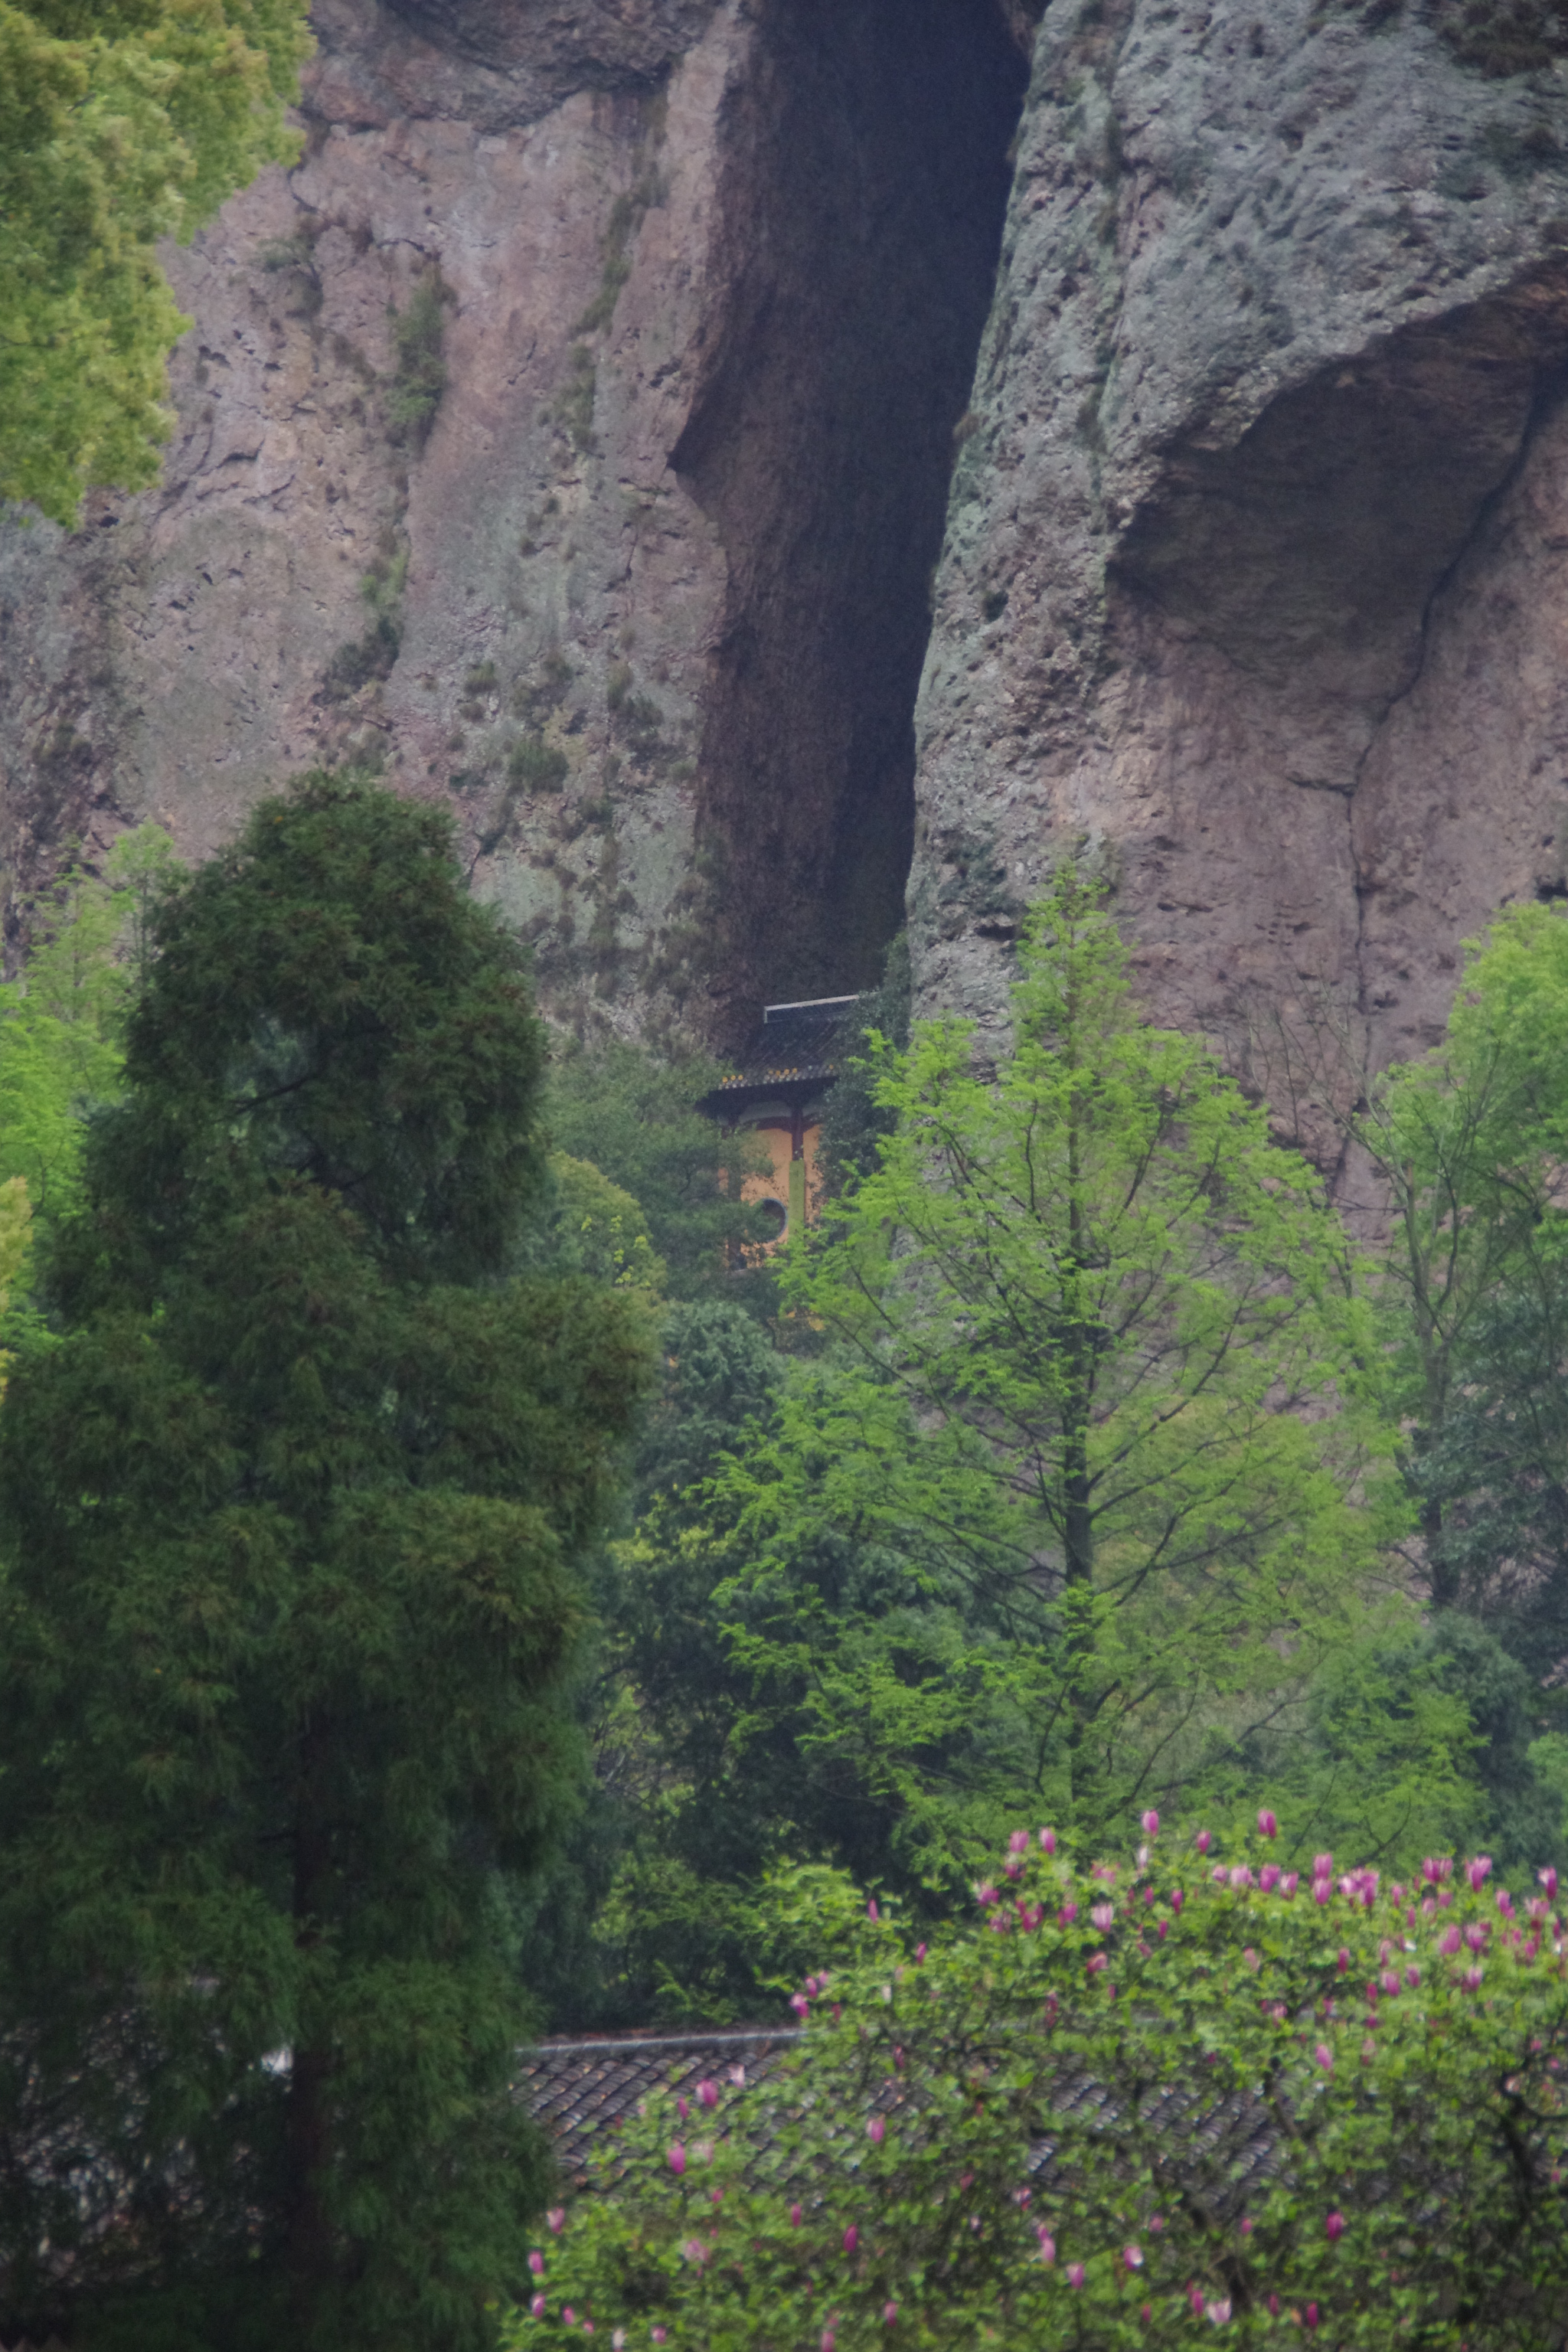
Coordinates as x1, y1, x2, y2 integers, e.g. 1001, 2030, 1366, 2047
672, 0, 1027, 1037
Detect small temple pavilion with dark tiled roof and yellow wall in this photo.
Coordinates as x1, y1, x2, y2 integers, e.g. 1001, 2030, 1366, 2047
698, 998, 863, 1246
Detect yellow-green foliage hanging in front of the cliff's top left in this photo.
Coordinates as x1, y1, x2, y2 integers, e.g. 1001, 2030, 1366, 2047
0, 0, 310, 524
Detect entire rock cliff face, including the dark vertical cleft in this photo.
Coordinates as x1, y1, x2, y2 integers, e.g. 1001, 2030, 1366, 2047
0, 0, 1568, 1091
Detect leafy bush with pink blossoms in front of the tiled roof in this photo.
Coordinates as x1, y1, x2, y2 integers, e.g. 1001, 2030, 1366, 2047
505, 1811, 1568, 2352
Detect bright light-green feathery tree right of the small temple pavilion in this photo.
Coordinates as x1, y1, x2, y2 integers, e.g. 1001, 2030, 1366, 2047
720, 875, 1392, 1839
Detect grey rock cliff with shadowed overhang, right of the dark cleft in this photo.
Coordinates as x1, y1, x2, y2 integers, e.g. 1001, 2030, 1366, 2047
910, 0, 1568, 1148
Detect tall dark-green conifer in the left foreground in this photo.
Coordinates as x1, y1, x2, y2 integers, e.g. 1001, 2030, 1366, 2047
0, 776, 648, 2352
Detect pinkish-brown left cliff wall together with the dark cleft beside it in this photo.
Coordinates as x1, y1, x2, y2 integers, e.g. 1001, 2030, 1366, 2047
0, 0, 1027, 1033
